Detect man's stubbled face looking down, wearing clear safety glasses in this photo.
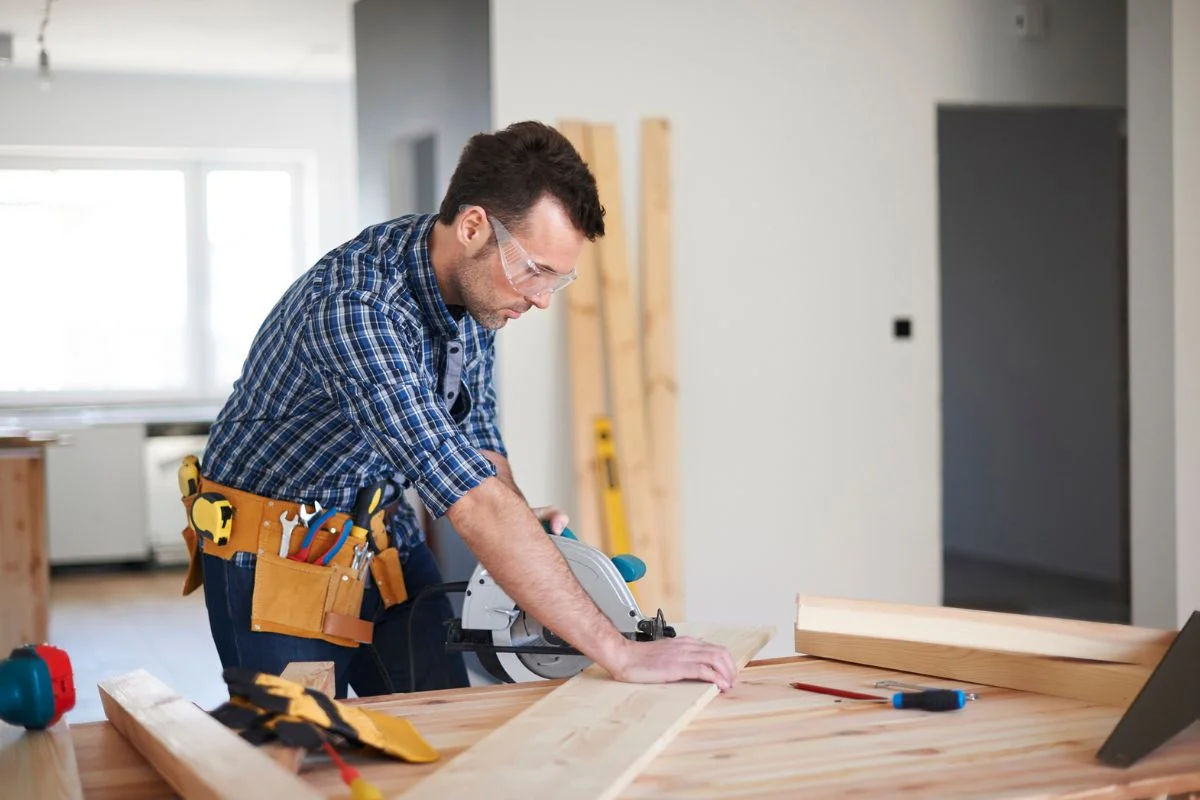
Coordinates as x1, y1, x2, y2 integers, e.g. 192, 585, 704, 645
457, 198, 584, 330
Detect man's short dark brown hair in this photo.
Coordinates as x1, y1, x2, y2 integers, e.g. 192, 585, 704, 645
438, 121, 605, 241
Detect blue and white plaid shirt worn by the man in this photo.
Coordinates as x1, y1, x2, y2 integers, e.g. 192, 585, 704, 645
203, 215, 506, 549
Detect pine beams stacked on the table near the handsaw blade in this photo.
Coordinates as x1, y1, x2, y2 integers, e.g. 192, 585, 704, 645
796, 595, 1175, 708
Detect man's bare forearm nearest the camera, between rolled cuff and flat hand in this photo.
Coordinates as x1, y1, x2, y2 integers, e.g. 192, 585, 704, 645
449, 479, 629, 670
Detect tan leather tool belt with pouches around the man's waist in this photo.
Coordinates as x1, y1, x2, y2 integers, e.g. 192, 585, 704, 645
182, 475, 408, 648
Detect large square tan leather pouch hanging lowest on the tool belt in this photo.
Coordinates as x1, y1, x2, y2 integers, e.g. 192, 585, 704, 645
250, 552, 373, 648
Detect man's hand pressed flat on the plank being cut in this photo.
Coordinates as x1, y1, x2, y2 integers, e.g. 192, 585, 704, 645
608, 636, 738, 692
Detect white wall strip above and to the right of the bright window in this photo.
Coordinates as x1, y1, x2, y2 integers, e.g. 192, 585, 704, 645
0, 71, 358, 260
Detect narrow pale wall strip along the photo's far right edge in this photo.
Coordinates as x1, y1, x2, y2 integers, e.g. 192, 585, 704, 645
1171, 0, 1200, 625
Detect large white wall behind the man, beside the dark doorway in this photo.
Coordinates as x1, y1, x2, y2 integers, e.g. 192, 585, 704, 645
492, 0, 1124, 654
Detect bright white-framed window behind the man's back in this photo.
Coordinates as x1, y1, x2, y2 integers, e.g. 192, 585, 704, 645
0, 158, 307, 405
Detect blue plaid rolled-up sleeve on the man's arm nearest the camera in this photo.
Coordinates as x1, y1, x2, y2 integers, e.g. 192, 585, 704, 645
300, 290, 496, 517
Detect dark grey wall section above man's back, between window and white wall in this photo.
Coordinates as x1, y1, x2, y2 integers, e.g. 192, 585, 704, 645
354, 0, 492, 225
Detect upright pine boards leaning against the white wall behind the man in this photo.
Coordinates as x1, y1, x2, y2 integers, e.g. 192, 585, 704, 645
559, 119, 683, 622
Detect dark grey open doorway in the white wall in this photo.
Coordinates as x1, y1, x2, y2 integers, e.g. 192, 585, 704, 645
937, 106, 1130, 622
